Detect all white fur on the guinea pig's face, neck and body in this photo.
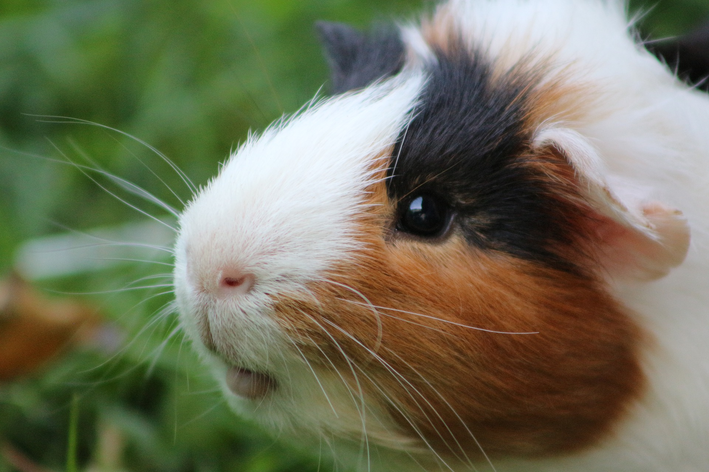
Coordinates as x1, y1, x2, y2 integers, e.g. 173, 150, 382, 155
175, 0, 709, 472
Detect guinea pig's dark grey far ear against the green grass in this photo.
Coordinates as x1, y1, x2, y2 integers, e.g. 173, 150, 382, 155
315, 21, 405, 94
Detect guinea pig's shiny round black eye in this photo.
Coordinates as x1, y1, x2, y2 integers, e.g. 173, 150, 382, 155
398, 194, 450, 237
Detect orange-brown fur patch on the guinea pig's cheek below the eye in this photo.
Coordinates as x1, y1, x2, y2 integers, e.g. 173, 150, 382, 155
276, 157, 643, 457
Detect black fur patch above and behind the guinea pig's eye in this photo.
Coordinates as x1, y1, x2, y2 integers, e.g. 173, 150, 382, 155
388, 48, 575, 270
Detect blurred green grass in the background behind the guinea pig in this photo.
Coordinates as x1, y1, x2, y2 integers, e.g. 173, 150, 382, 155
0, 0, 709, 472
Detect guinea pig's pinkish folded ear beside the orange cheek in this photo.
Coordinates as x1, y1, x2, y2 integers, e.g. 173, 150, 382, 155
534, 128, 690, 280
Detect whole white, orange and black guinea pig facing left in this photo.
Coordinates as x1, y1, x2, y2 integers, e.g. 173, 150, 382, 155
174, 0, 709, 472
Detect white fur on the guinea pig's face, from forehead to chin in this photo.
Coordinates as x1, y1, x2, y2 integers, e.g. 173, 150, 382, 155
175, 75, 423, 466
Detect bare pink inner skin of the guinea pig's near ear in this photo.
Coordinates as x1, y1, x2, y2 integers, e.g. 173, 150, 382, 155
597, 202, 690, 281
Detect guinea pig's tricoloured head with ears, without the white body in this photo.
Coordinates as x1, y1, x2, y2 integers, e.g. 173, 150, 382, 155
175, 25, 689, 464
